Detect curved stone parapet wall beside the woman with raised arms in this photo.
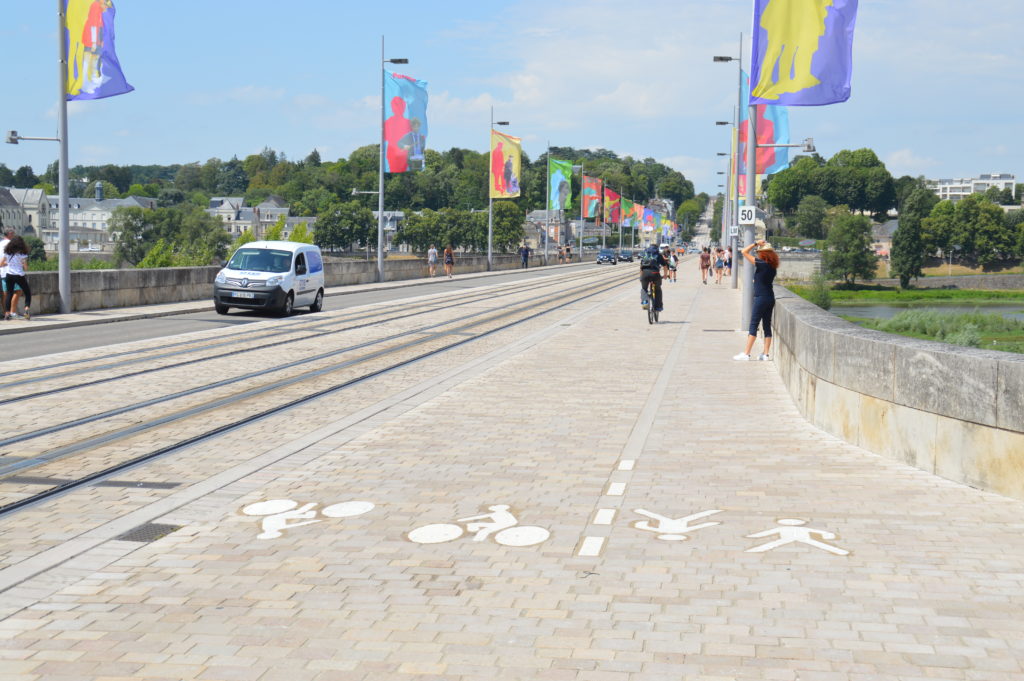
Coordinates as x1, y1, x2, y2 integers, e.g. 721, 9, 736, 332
773, 287, 1024, 499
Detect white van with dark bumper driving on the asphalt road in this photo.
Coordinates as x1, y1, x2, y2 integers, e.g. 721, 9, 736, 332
213, 242, 324, 316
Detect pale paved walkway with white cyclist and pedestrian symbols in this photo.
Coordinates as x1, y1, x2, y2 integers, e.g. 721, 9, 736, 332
0, 269, 1024, 681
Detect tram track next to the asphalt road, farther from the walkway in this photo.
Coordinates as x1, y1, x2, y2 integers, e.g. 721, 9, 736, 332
0, 272, 595, 406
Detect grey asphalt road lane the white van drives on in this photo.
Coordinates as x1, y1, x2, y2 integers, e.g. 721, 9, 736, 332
8, 262, 602, 359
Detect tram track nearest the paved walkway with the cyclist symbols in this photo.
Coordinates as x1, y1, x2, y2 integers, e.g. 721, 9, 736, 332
0, 272, 633, 516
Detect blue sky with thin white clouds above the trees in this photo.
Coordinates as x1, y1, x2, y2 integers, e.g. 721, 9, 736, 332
0, 0, 1024, 193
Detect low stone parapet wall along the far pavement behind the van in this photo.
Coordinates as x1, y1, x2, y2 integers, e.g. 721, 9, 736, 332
29, 254, 528, 314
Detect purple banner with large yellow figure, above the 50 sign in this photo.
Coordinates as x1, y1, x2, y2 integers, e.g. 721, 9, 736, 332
750, 0, 857, 107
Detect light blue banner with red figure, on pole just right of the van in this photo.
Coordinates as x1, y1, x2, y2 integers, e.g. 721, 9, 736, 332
384, 71, 427, 173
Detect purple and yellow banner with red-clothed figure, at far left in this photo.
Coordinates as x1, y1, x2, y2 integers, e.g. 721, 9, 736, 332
65, 0, 135, 101
